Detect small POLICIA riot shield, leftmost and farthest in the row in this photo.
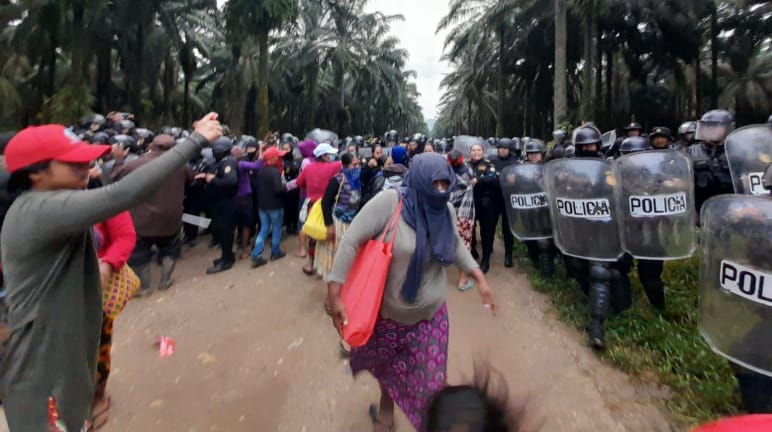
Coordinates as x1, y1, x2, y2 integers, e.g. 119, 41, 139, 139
499, 164, 552, 241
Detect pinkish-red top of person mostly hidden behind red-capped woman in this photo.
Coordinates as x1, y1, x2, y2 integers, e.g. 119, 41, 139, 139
94, 211, 137, 271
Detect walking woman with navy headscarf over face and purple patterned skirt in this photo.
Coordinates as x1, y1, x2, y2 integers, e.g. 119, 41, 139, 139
326, 153, 496, 432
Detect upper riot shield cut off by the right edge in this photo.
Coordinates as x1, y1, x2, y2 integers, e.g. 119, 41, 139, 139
724, 124, 772, 195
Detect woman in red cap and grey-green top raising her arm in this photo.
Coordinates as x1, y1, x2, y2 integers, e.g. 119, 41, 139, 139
0, 113, 222, 431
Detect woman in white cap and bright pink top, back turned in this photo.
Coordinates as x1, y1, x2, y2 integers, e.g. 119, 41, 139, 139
296, 143, 341, 276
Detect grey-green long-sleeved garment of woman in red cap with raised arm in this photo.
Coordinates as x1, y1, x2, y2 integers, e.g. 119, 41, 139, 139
0, 133, 206, 431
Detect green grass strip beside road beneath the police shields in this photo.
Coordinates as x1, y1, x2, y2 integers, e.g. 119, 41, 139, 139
516, 245, 741, 427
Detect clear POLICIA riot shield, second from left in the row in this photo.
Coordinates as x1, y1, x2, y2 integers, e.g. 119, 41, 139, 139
544, 158, 622, 261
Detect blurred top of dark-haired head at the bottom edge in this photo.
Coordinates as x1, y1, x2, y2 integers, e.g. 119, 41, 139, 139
426, 367, 524, 432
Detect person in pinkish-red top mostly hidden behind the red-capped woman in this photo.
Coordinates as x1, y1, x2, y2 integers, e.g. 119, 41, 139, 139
90, 210, 136, 430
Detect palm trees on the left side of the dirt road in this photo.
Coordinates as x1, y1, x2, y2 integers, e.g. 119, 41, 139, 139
0, 0, 424, 134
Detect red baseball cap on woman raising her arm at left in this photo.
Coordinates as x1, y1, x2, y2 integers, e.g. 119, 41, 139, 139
5, 124, 110, 173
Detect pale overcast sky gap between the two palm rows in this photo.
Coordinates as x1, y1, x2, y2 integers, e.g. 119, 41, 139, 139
367, 0, 449, 119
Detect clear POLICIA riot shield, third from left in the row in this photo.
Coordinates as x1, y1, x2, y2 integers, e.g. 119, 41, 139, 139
613, 150, 697, 260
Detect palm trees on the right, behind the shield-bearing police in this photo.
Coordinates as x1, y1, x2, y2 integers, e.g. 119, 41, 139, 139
435, 0, 772, 136
